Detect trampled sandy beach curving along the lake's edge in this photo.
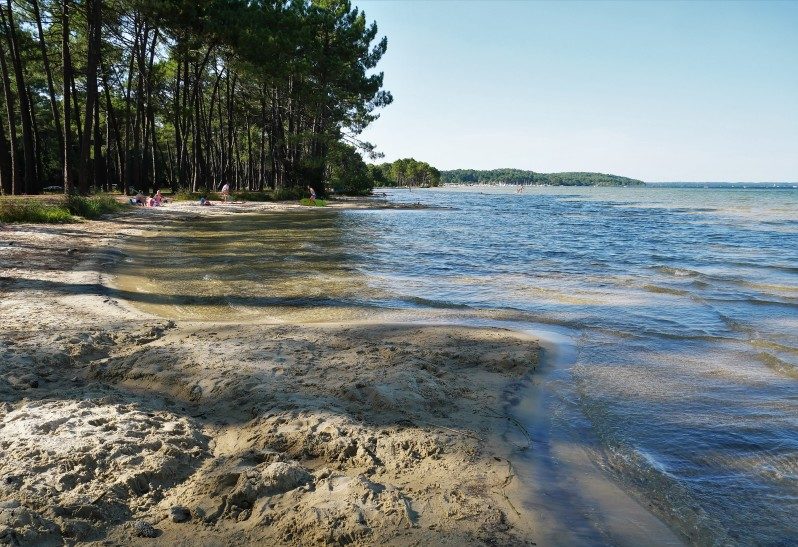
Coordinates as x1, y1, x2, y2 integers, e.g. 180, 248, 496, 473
0, 204, 539, 545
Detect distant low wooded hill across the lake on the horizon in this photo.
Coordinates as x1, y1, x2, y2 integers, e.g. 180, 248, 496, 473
441, 169, 645, 186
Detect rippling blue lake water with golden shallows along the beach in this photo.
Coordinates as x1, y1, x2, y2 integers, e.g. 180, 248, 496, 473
118, 187, 798, 545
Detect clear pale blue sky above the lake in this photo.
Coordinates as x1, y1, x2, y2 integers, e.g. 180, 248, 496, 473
353, 0, 798, 182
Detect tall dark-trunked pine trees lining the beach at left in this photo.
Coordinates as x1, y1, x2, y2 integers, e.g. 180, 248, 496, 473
0, 0, 392, 194
